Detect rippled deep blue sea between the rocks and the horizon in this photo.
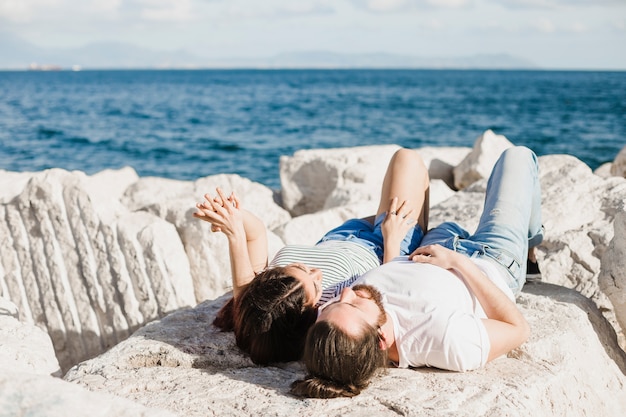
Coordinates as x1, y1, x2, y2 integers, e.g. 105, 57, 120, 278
0, 70, 626, 189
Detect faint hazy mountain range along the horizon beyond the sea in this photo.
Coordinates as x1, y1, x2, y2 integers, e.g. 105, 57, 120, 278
0, 33, 536, 69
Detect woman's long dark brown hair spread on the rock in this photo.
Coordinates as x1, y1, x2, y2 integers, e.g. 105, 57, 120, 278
213, 267, 317, 365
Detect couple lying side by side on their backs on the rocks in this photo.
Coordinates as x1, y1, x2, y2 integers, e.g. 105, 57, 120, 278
194, 147, 543, 398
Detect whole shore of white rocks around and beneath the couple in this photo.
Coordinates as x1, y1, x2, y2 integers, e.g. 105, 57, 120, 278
0, 131, 626, 416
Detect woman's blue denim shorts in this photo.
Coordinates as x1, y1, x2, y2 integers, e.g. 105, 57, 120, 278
317, 213, 424, 263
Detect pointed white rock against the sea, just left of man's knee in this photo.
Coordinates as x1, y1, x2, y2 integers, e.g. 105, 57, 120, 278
454, 130, 513, 190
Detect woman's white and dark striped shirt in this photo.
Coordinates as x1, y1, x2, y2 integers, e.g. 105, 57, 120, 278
270, 240, 380, 306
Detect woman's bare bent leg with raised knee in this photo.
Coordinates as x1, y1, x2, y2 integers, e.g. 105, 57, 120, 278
376, 148, 430, 233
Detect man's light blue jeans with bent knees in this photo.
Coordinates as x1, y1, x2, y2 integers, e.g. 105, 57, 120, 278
420, 146, 543, 294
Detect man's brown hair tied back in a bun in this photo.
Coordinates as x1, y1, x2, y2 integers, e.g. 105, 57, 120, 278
291, 321, 387, 398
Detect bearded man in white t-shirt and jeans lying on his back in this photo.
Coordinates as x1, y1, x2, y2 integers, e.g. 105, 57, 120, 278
292, 147, 543, 398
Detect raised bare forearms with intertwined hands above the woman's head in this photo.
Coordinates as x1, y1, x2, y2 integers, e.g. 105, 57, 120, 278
193, 188, 267, 297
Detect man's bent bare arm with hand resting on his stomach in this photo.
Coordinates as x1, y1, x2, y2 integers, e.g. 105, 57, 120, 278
411, 245, 530, 361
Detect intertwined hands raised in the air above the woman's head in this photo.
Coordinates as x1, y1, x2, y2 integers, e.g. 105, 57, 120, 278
193, 187, 243, 236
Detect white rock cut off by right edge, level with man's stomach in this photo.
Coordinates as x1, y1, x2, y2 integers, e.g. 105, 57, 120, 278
598, 211, 626, 333
